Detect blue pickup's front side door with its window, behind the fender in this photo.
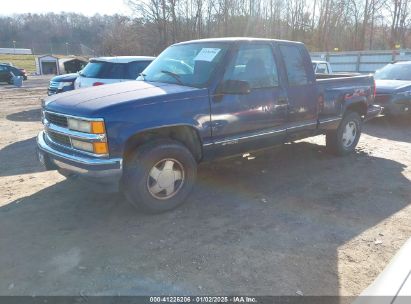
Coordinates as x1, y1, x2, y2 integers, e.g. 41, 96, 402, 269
211, 43, 287, 154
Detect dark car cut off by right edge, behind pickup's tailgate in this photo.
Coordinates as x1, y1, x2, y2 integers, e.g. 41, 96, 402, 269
374, 61, 411, 115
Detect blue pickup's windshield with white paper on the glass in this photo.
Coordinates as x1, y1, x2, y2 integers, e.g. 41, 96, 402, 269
138, 43, 228, 88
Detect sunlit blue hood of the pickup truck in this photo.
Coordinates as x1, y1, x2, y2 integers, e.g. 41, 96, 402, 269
44, 80, 207, 117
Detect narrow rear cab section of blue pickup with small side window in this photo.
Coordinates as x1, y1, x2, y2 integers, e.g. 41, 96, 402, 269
279, 43, 318, 133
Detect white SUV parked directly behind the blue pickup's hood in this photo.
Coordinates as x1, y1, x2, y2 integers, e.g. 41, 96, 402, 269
74, 56, 154, 89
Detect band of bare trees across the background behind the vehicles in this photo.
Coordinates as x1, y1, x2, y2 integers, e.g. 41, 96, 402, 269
0, 0, 411, 55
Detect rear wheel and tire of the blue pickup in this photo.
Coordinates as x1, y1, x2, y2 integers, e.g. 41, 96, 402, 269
326, 112, 362, 156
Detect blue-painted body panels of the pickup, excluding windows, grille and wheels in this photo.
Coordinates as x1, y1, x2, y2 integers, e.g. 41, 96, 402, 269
38, 38, 380, 180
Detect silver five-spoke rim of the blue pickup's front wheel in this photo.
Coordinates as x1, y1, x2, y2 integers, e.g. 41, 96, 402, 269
147, 158, 184, 200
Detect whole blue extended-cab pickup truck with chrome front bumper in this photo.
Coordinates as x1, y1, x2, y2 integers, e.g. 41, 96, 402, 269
37, 38, 380, 213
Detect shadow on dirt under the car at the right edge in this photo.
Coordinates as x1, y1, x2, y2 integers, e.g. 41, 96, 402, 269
364, 115, 411, 143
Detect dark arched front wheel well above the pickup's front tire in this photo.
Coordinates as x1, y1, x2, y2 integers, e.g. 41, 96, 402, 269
123, 126, 202, 161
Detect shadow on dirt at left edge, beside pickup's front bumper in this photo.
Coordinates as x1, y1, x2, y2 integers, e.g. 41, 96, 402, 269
0, 137, 44, 176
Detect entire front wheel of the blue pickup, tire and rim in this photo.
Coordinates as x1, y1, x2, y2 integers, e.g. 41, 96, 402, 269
123, 139, 197, 213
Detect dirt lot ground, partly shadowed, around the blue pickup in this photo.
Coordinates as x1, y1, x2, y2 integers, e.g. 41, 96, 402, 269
0, 78, 411, 295
